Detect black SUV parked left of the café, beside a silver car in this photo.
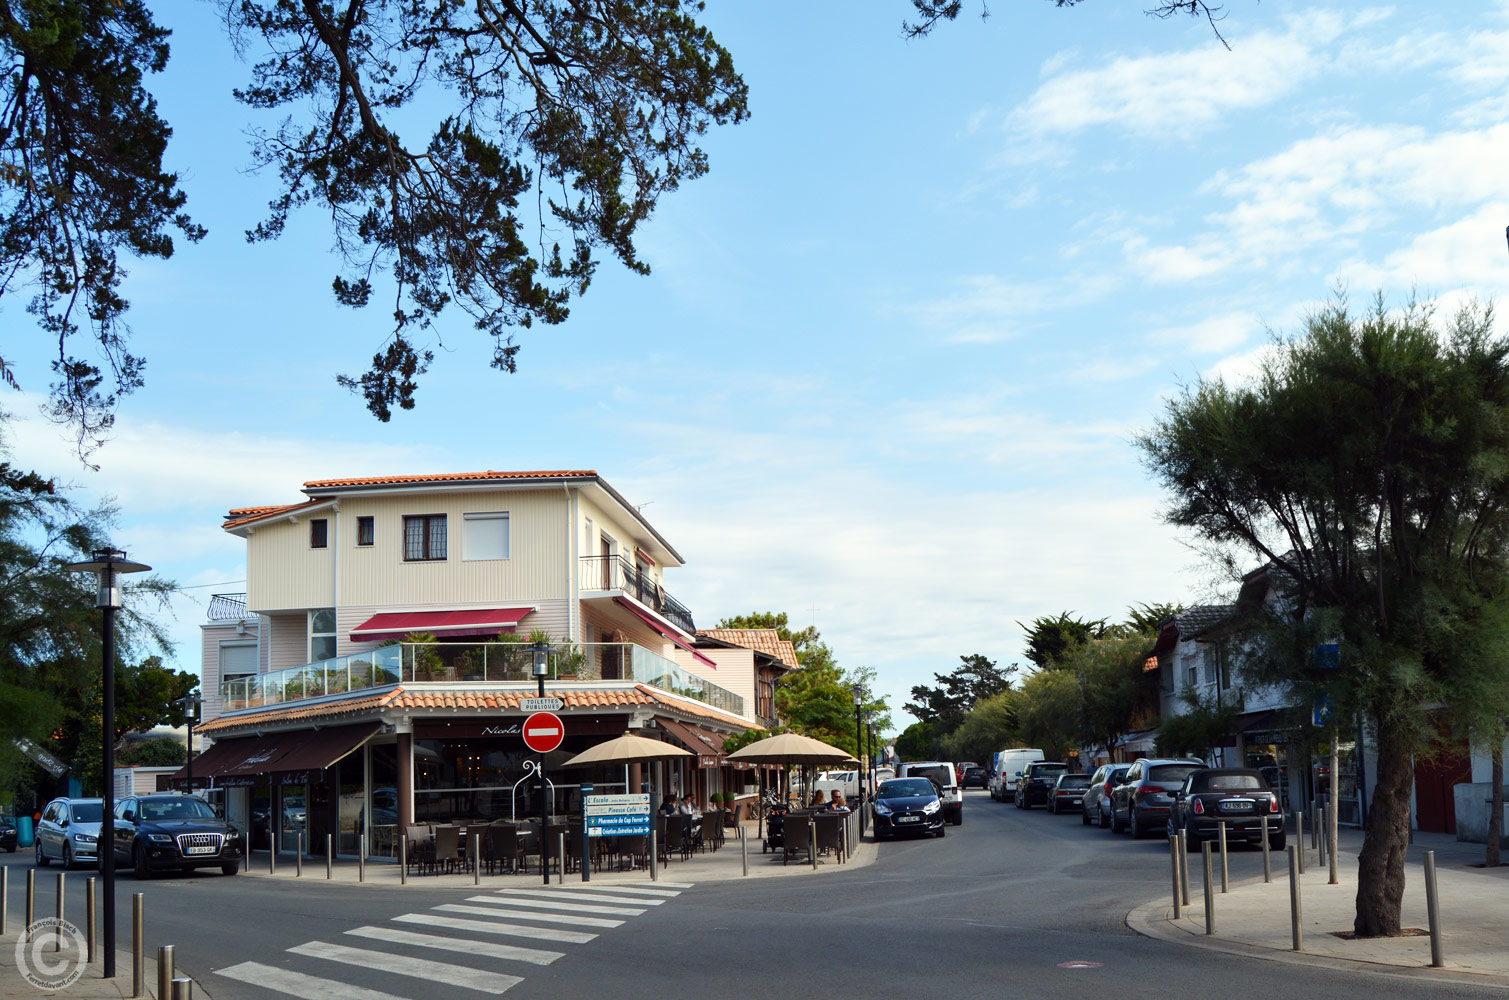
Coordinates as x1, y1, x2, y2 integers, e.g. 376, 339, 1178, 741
115, 792, 246, 878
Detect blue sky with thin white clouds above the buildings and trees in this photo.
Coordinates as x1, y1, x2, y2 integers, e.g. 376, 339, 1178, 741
0, 0, 1509, 736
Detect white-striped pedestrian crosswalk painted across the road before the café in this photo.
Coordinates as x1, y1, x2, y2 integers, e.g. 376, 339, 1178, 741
214, 882, 693, 1000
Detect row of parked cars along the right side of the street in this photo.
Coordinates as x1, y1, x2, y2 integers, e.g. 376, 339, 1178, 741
987, 748, 1286, 851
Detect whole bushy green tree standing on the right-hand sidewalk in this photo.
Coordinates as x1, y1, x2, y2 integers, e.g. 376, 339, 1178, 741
1138, 296, 1509, 937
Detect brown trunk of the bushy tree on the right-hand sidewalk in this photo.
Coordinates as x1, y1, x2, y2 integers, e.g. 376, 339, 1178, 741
1352, 725, 1414, 938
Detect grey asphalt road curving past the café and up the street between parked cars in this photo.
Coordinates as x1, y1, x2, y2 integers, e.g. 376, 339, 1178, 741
5, 790, 1501, 1000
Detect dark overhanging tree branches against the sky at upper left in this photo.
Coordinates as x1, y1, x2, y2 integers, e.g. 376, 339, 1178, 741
0, 0, 748, 452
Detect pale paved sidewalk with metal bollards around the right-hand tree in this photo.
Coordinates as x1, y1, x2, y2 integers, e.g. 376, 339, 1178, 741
1127, 830, 1509, 986
